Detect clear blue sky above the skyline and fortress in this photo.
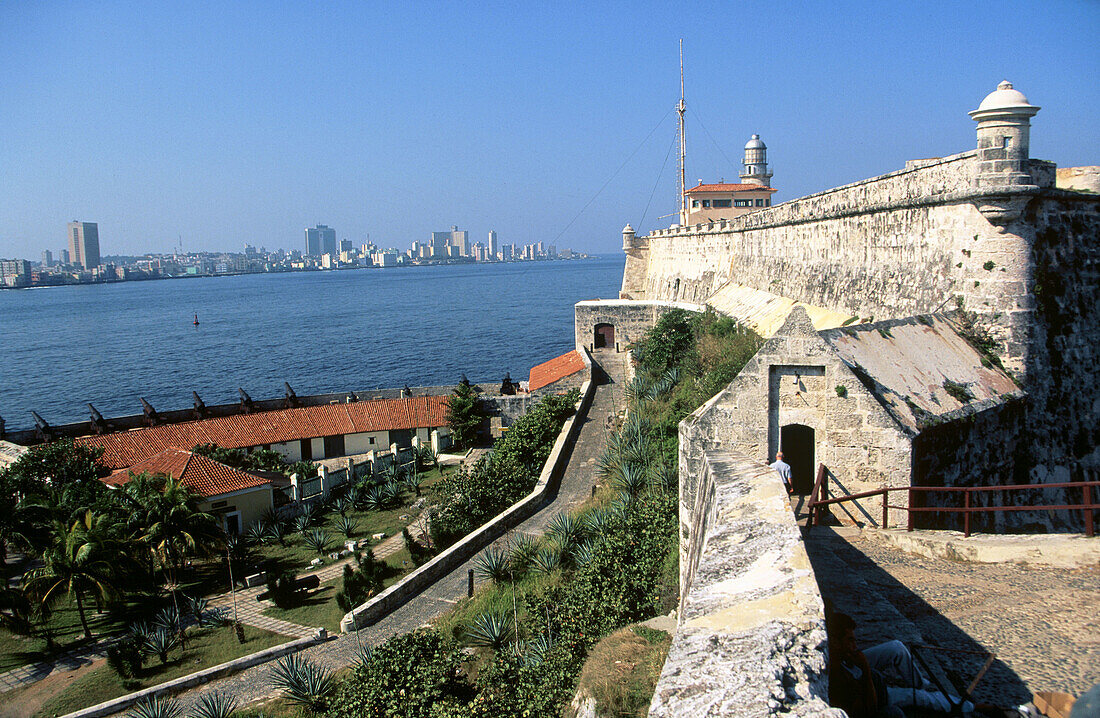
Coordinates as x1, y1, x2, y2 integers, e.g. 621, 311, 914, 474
0, 0, 1100, 259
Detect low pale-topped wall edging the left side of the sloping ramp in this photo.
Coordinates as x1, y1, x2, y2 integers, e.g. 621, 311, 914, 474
340, 379, 595, 633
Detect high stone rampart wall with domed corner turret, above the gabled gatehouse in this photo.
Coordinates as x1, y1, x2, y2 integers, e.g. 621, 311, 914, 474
620, 82, 1100, 492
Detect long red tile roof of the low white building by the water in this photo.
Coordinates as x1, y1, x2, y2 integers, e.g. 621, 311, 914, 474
76, 396, 447, 468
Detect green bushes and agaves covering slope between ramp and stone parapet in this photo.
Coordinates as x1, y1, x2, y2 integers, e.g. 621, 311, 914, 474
312, 311, 761, 718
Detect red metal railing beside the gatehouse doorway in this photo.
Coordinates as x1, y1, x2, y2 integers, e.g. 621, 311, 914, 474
806, 464, 1100, 537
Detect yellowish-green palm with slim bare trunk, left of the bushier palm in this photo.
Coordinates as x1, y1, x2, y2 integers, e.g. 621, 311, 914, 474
26, 510, 119, 639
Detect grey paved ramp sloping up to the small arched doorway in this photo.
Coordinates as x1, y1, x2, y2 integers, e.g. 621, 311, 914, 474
171, 352, 626, 709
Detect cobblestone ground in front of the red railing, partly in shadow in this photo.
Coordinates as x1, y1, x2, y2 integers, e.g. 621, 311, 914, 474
807, 530, 1100, 706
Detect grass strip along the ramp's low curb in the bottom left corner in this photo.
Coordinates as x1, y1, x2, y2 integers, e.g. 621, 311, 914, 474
16, 626, 290, 718
